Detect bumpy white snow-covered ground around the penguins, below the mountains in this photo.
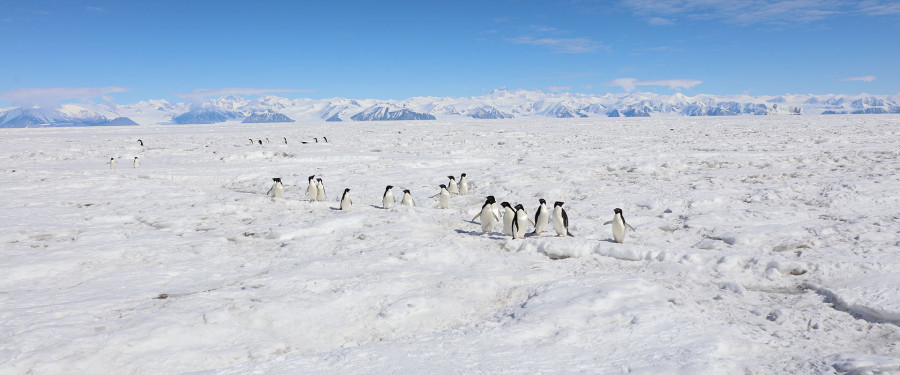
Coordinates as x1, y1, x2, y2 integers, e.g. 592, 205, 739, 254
0, 115, 900, 374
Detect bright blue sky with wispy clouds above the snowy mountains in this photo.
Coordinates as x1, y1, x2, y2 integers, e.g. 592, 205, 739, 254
0, 0, 900, 106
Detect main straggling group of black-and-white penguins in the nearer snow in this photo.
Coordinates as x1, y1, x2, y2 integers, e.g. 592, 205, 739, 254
266, 173, 634, 243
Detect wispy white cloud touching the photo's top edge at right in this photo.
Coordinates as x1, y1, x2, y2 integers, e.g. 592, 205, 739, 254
621, 0, 848, 25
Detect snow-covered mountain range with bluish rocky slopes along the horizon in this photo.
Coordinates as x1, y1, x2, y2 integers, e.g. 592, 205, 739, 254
0, 89, 900, 128
